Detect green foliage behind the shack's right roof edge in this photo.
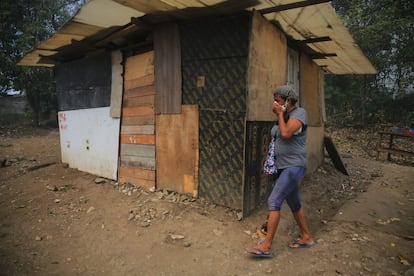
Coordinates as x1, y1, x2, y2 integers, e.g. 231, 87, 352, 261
325, 0, 414, 126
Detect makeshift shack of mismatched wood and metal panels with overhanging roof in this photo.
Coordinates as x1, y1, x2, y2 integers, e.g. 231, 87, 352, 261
20, 0, 376, 215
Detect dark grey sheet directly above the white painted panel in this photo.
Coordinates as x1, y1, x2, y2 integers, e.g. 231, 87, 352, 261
55, 53, 112, 111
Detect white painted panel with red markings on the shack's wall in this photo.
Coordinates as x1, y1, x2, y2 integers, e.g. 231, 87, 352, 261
58, 107, 120, 180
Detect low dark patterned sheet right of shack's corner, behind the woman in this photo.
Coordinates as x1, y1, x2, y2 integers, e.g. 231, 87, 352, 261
243, 122, 275, 216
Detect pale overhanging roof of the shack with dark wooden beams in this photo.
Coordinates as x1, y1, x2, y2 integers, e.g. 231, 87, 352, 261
19, 0, 376, 74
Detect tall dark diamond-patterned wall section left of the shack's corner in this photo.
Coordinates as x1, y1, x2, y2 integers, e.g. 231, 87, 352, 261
180, 15, 250, 209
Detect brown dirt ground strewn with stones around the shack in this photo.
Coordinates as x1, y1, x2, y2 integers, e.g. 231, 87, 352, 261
0, 127, 414, 275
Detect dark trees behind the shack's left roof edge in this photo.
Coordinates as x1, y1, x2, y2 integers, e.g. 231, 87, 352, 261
0, 0, 85, 125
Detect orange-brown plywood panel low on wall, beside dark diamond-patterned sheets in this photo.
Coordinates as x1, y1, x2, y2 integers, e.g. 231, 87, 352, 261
156, 105, 199, 196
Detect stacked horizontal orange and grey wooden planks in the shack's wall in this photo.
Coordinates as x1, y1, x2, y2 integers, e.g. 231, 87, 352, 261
118, 51, 155, 187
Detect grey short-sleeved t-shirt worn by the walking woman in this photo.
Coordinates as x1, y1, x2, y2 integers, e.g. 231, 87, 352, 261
271, 107, 308, 169
